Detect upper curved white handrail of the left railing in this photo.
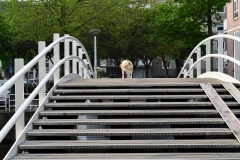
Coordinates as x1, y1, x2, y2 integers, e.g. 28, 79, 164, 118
0, 35, 93, 95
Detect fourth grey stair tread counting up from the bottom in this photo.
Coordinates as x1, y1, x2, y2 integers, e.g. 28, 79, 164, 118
34, 118, 224, 125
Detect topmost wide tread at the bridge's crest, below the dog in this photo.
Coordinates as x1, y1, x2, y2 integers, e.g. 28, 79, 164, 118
58, 78, 223, 87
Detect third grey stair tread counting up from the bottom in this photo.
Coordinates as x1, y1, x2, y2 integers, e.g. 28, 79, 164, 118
27, 128, 232, 136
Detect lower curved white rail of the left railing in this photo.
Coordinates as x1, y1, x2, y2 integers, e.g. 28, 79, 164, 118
0, 56, 91, 143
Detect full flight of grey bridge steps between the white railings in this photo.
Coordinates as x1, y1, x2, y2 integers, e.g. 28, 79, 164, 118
9, 78, 240, 160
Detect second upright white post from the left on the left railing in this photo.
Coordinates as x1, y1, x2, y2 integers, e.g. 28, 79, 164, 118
38, 41, 46, 105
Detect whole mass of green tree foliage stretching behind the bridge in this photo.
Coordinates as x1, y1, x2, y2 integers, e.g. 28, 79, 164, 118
0, 0, 230, 77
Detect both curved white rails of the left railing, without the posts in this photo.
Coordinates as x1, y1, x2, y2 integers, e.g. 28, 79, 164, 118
0, 35, 93, 142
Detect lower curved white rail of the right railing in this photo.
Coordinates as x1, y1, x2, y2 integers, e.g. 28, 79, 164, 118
184, 54, 240, 78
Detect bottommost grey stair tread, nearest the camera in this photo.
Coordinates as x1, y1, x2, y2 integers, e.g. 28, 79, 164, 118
12, 152, 240, 160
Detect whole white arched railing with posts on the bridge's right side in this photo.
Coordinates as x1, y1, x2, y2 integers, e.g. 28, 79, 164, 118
177, 34, 240, 80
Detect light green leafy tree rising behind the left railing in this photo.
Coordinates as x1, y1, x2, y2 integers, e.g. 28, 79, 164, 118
0, 0, 139, 75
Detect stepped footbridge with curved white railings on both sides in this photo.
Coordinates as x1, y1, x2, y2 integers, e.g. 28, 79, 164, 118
0, 34, 240, 160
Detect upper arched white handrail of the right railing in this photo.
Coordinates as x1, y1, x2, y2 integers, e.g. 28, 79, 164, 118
177, 34, 240, 78
